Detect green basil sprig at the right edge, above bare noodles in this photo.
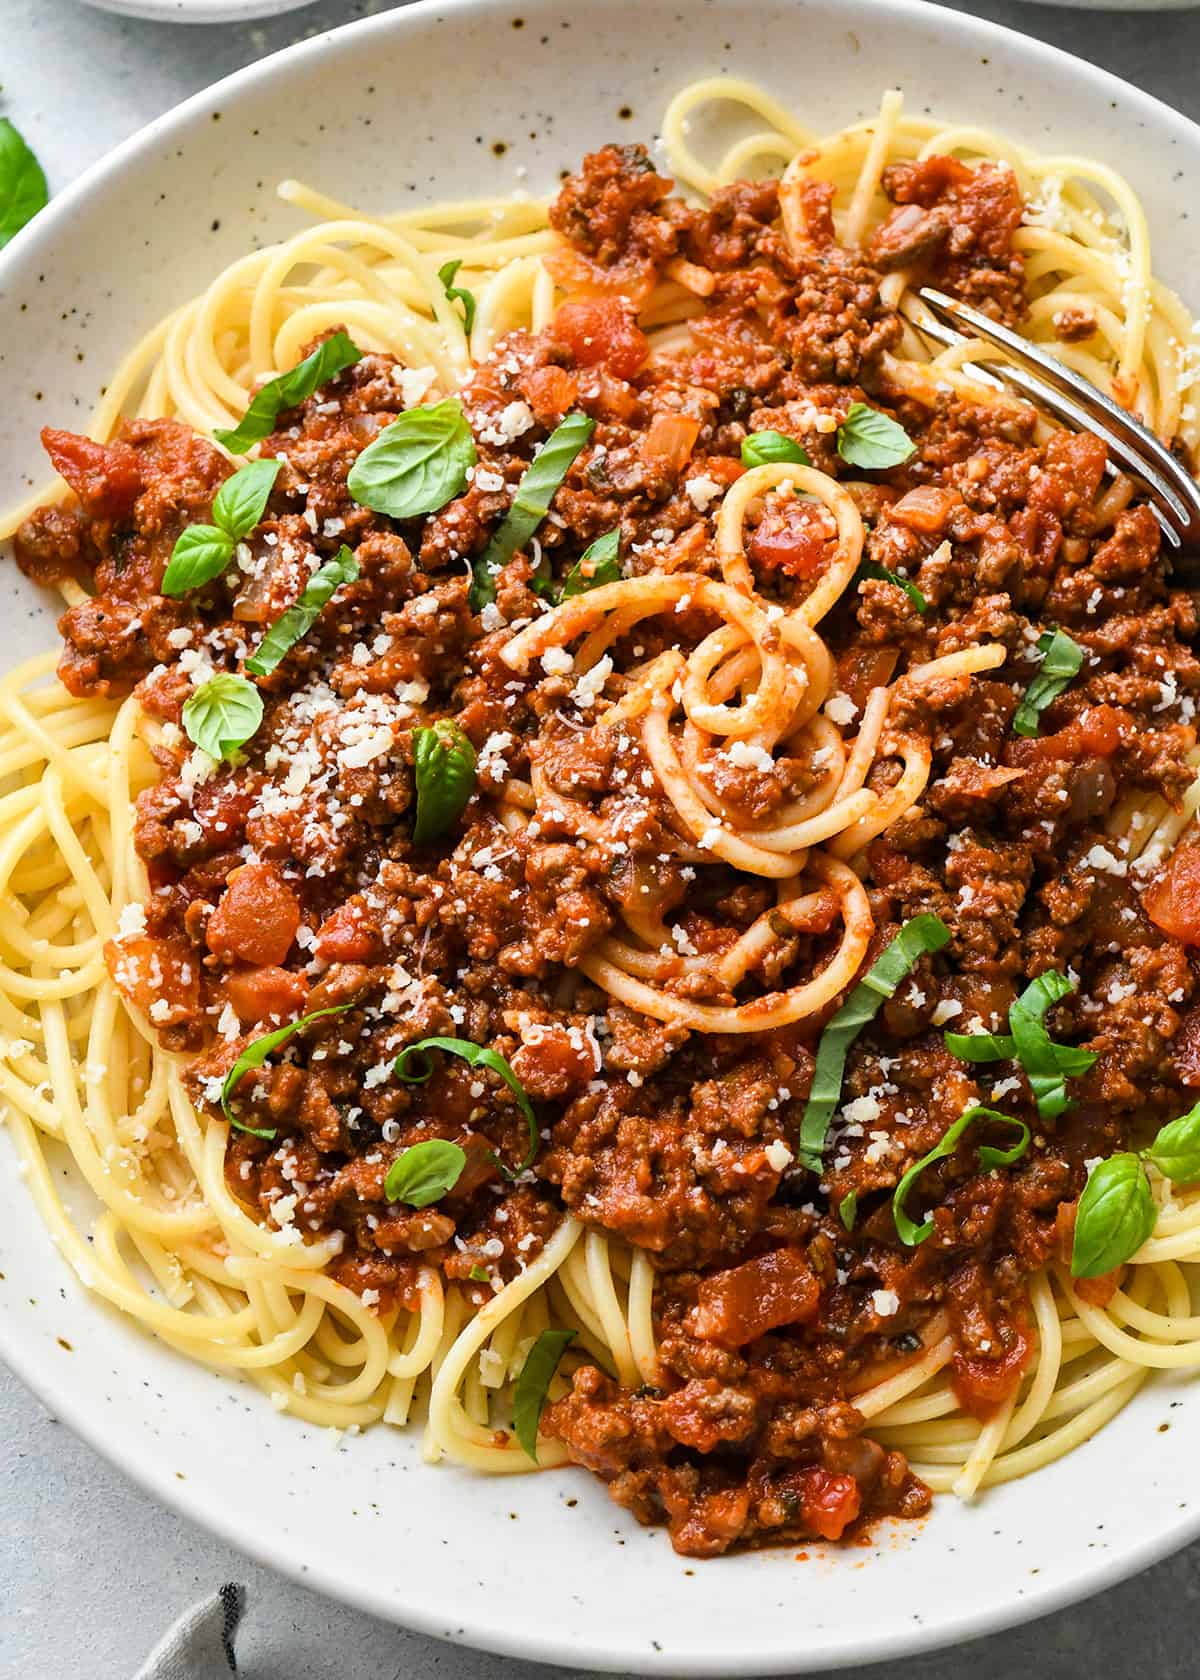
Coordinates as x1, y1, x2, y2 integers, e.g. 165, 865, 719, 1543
1071, 1102, 1200, 1277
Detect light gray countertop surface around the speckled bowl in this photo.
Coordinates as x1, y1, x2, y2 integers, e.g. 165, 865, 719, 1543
0, 0, 1200, 1680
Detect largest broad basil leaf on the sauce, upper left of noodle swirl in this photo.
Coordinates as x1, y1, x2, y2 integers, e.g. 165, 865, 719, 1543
346, 396, 477, 519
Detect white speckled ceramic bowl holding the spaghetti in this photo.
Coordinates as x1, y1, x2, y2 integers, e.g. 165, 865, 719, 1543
0, 0, 1200, 1677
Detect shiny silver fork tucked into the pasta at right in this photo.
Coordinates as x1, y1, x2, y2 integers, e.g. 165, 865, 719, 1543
913, 286, 1200, 588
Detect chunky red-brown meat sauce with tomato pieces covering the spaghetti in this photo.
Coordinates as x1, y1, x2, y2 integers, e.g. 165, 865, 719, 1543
17, 148, 1200, 1556
